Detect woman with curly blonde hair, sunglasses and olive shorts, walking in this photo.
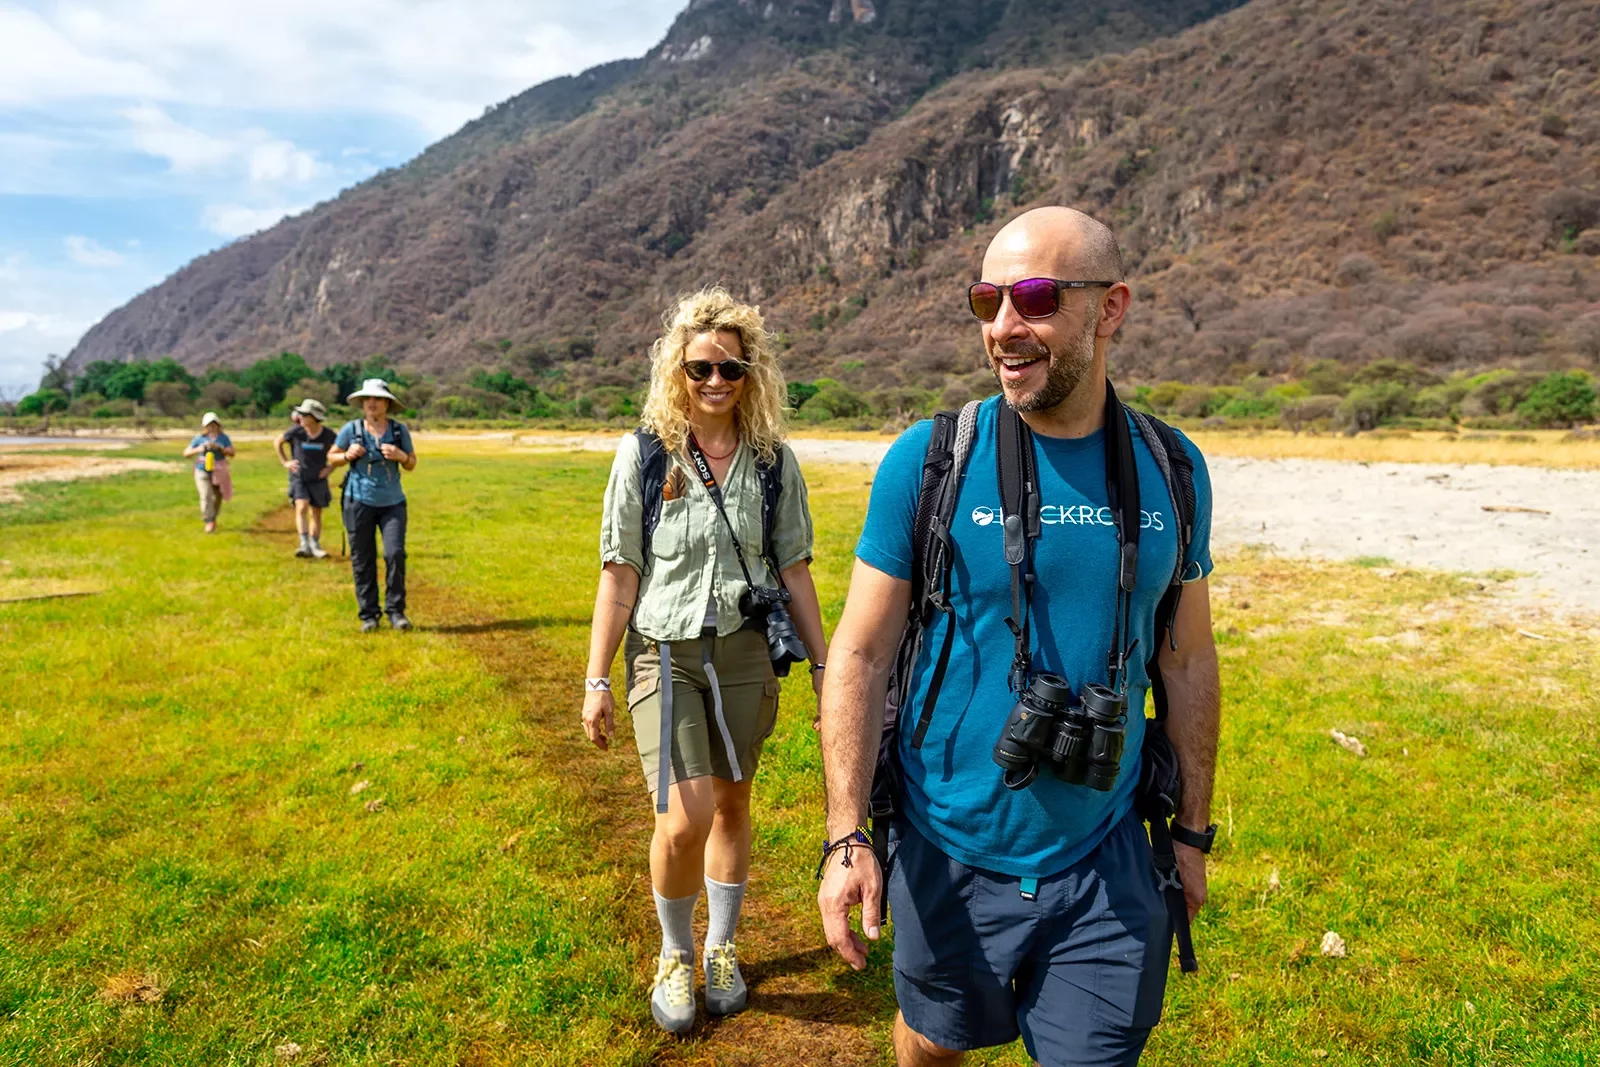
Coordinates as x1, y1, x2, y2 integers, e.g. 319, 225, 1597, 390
582, 290, 827, 1033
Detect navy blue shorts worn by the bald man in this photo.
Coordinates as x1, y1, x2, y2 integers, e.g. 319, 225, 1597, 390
888, 813, 1173, 1067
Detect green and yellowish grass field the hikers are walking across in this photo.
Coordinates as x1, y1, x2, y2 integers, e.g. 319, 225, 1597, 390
0, 438, 1600, 1065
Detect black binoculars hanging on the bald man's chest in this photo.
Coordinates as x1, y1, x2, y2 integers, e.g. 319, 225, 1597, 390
994, 675, 1128, 792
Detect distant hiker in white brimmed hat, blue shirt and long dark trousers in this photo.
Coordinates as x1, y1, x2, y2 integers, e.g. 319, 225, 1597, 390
328, 378, 416, 633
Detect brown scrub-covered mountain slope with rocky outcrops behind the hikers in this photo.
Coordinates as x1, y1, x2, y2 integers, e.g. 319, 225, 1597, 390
72, 0, 1600, 392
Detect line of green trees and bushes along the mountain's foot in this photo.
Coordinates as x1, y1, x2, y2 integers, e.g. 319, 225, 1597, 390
14, 352, 1600, 432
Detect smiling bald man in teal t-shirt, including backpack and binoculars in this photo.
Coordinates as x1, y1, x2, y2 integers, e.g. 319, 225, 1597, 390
818, 208, 1219, 1067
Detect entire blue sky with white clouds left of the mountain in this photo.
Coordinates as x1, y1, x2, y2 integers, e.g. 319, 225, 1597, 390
0, 0, 686, 397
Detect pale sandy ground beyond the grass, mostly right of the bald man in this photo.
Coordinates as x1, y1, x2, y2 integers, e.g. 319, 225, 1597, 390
518, 435, 1600, 616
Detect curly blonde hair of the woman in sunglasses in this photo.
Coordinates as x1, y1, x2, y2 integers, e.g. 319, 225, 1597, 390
640, 286, 789, 464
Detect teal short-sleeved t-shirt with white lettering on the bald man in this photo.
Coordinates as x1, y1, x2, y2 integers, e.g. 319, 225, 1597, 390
856, 397, 1211, 878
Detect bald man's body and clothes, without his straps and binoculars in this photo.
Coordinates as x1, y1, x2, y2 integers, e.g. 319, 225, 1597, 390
818, 208, 1219, 1067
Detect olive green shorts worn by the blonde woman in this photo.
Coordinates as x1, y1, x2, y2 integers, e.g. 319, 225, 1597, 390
626, 630, 778, 797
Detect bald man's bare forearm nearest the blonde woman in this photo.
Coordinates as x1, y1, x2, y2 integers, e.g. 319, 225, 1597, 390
821, 633, 888, 840
